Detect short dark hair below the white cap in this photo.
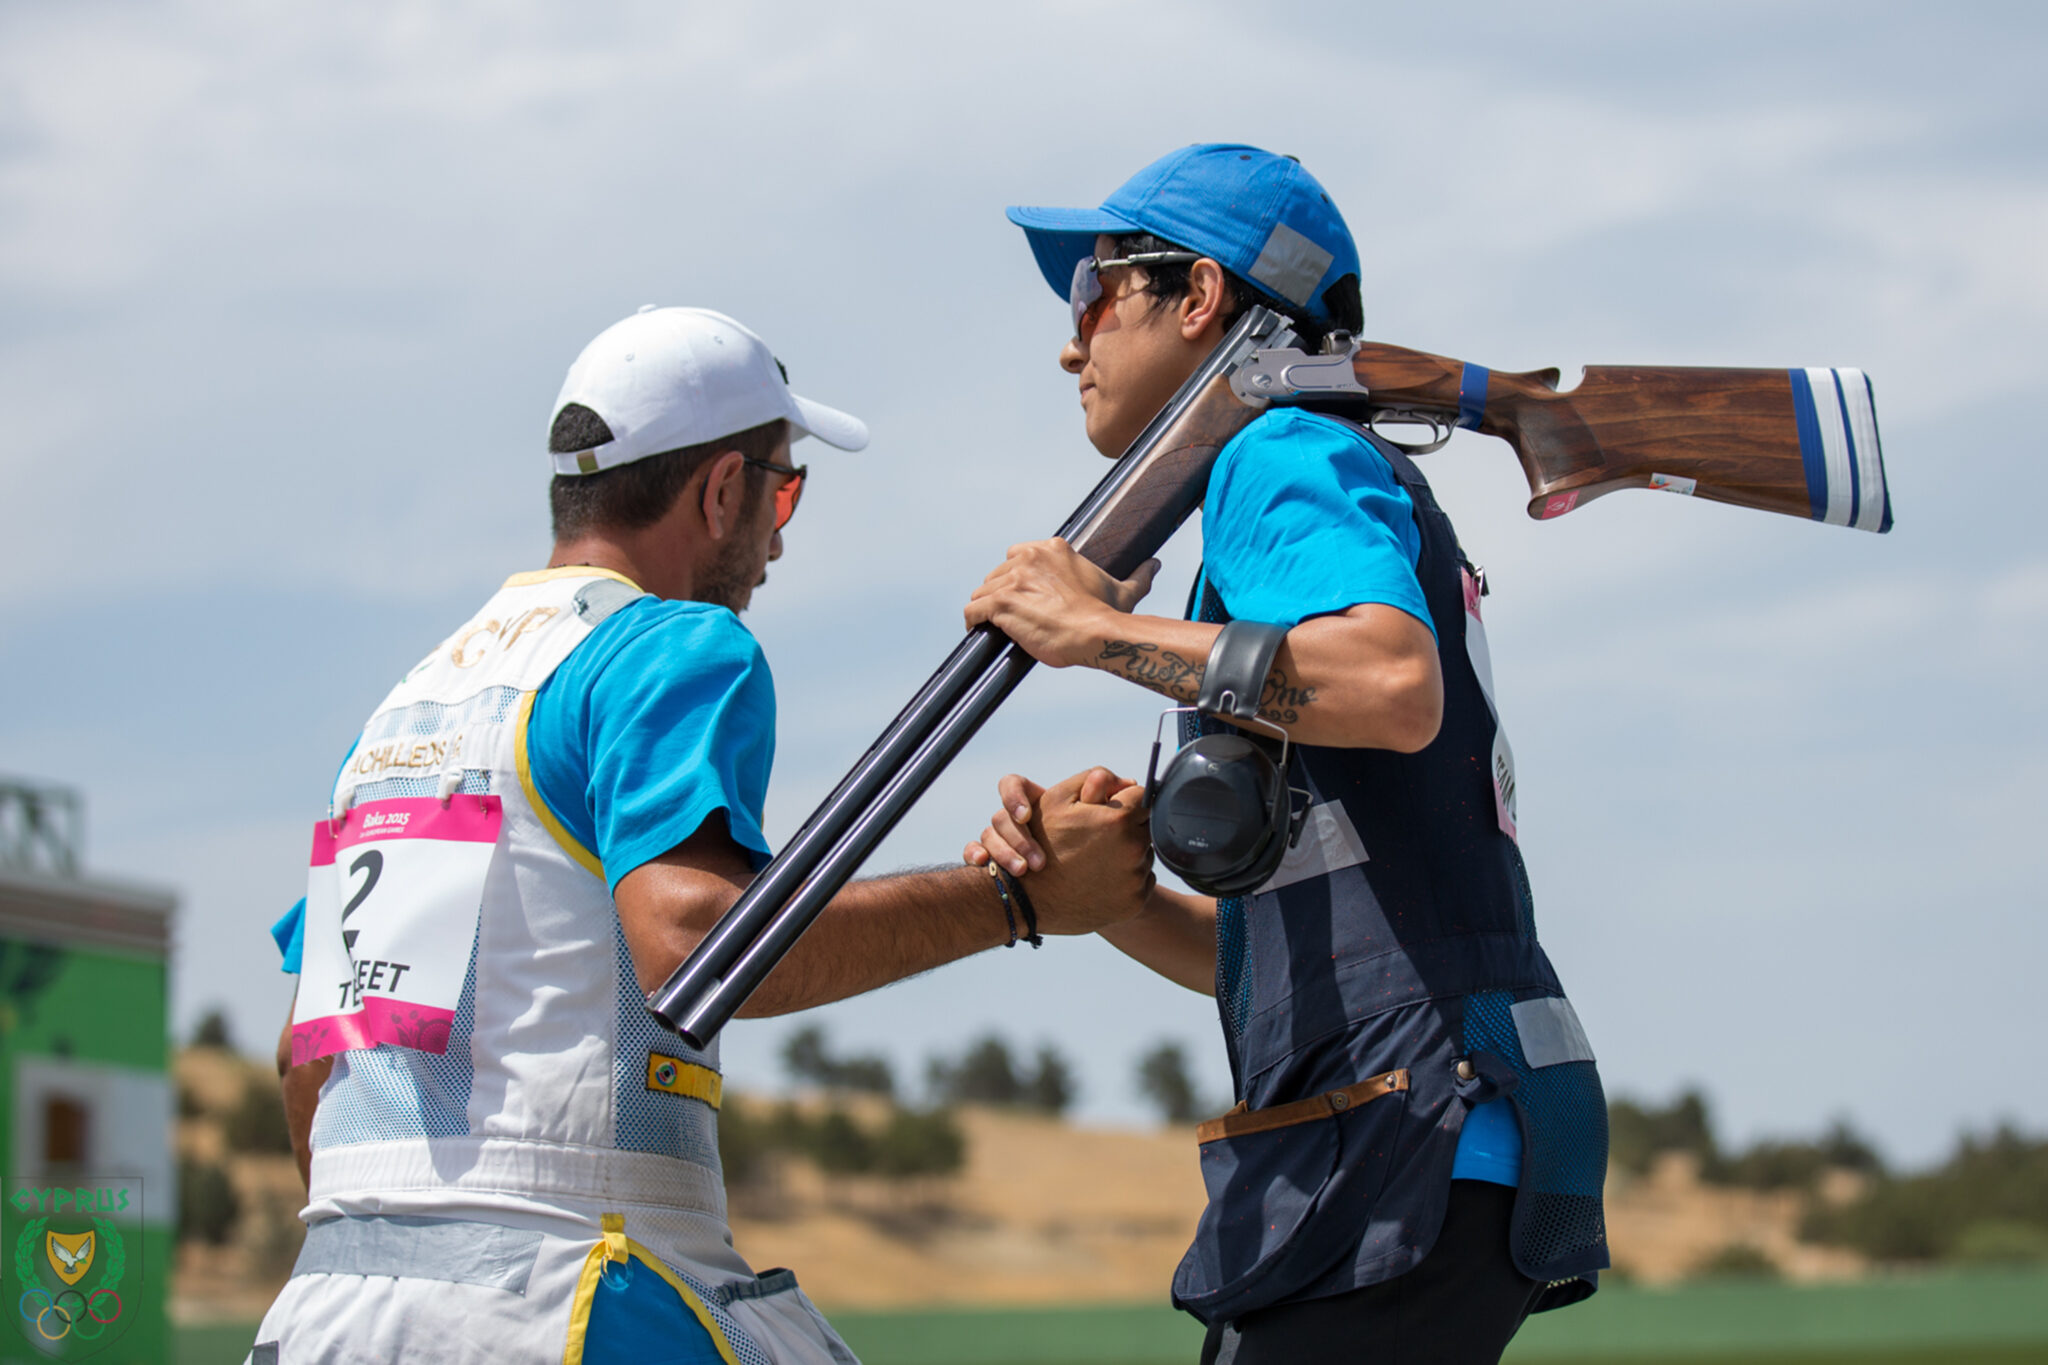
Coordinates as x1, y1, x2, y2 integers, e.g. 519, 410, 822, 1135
547, 403, 788, 540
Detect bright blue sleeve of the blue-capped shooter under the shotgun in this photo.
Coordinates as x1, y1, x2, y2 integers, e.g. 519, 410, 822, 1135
1202, 407, 1436, 634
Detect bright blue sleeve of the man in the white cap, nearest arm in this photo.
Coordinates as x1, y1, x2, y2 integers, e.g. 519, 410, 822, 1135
526, 598, 774, 888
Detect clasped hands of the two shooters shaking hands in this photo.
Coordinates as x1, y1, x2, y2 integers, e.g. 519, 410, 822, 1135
965, 767, 1157, 933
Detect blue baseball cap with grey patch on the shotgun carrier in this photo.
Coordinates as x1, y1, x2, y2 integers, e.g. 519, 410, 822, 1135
1008, 143, 1358, 323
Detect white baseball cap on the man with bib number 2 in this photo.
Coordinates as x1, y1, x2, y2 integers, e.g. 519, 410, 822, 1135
549, 303, 868, 475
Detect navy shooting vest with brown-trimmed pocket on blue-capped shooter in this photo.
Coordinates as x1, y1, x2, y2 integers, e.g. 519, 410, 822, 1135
1174, 423, 1608, 1322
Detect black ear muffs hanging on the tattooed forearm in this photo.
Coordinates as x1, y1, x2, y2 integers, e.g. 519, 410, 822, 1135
1145, 620, 1309, 896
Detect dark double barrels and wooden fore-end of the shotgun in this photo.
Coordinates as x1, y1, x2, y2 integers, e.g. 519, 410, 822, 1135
647, 307, 1294, 1048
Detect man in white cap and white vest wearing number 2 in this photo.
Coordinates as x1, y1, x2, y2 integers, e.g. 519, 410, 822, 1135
250, 307, 1149, 1365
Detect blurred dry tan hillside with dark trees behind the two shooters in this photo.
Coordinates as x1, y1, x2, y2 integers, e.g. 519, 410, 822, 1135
174, 1031, 2048, 1322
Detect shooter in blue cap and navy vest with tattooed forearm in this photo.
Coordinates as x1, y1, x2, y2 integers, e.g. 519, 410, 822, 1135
967, 145, 1608, 1365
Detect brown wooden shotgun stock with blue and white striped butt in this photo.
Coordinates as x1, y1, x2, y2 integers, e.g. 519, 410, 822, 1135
1352, 342, 1892, 532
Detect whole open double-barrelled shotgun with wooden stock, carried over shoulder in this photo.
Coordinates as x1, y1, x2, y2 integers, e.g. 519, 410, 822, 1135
647, 317, 1892, 1048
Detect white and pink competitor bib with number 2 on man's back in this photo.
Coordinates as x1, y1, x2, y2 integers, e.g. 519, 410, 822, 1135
291, 796, 504, 1066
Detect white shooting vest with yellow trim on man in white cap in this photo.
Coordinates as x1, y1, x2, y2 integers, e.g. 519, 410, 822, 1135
295, 569, 725, 1220
